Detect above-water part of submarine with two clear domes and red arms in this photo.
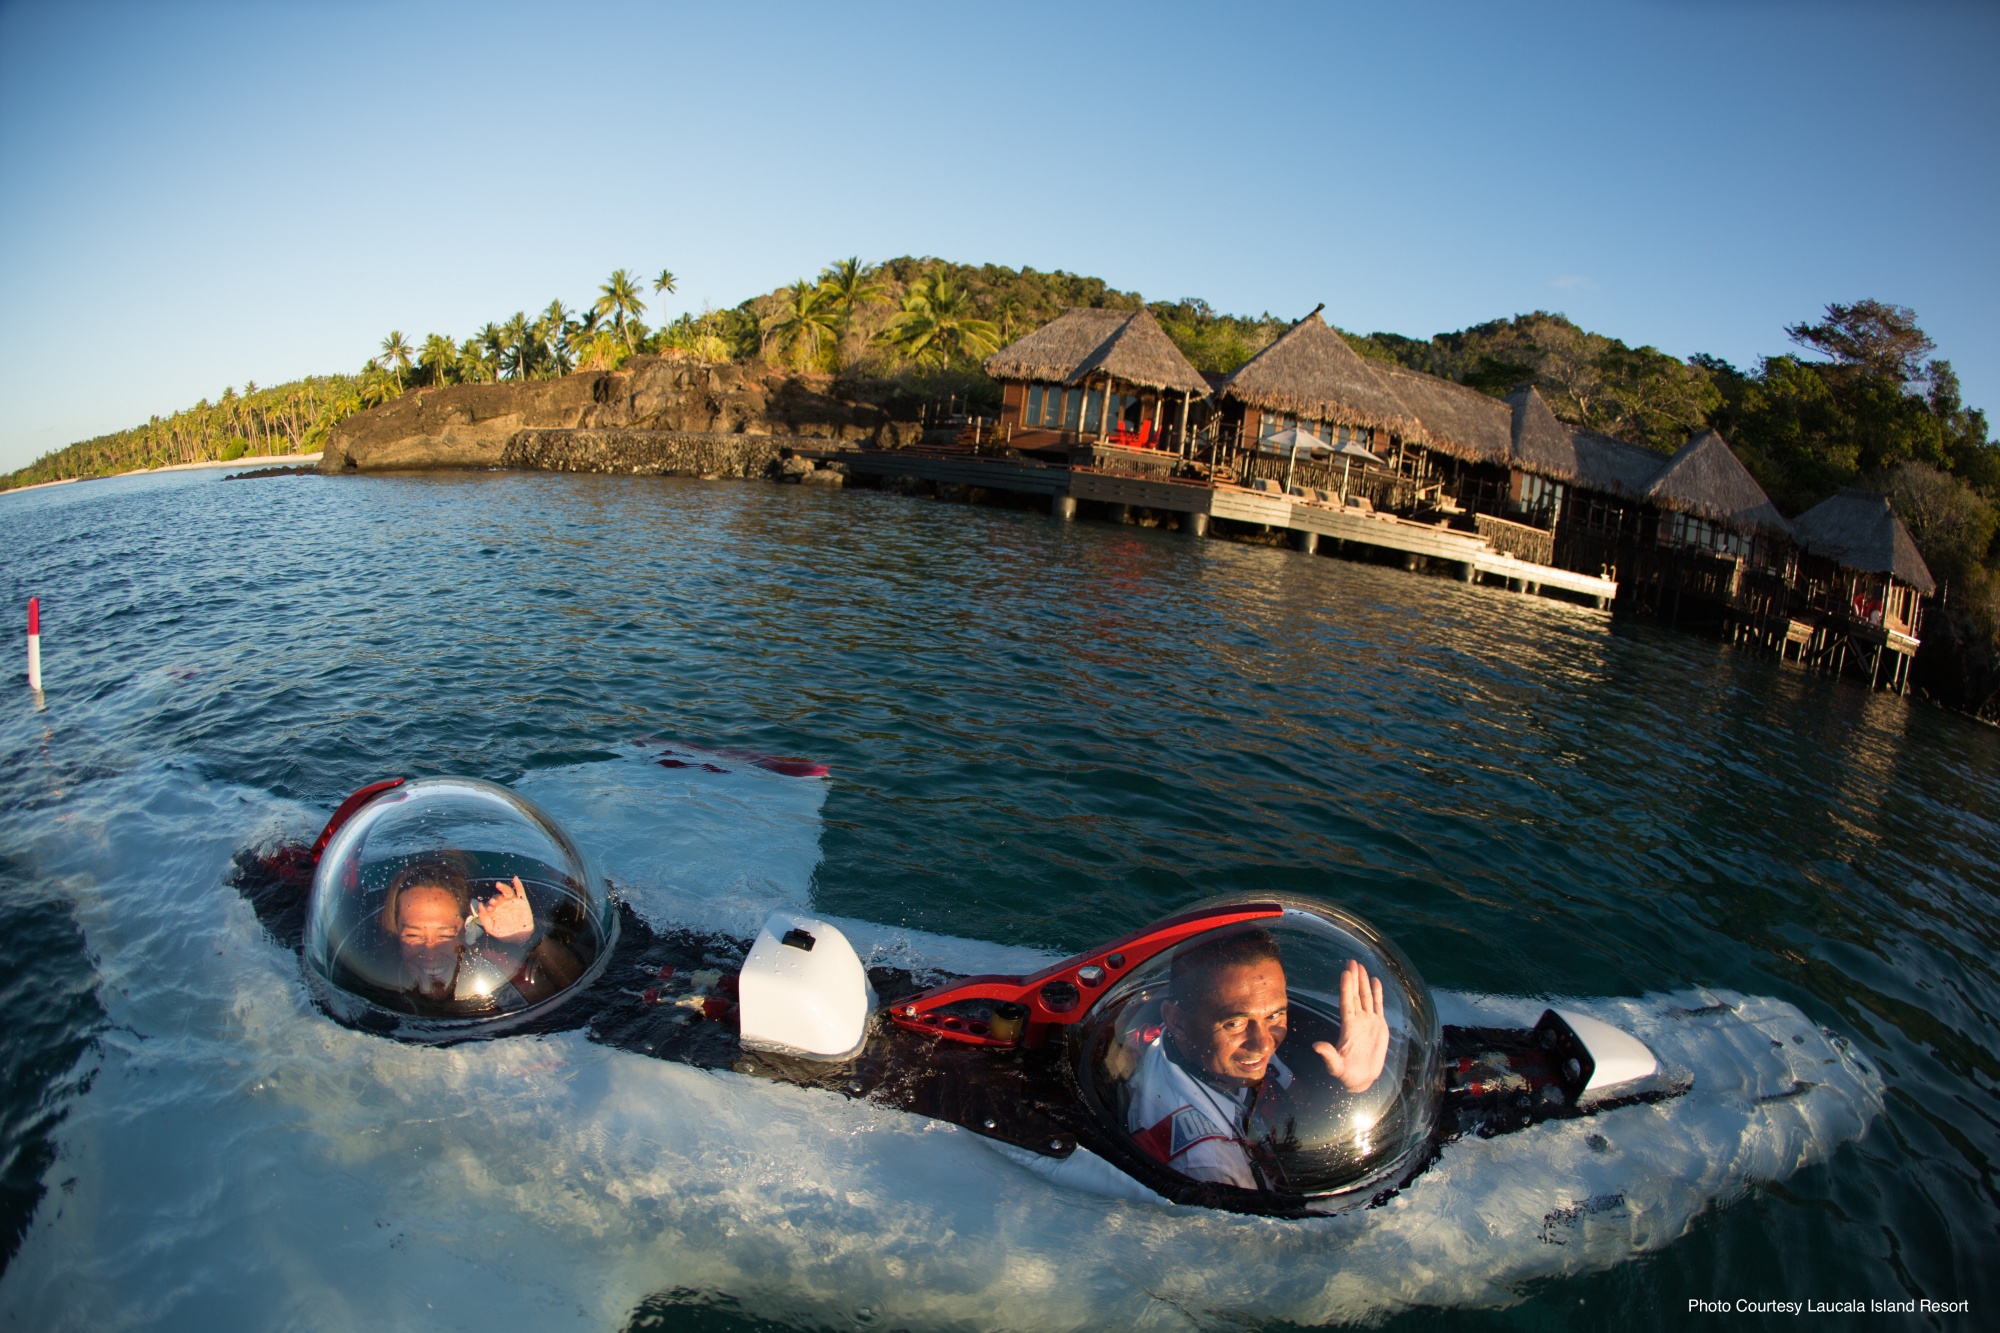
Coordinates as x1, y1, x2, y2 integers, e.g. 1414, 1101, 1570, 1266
242, 761, 1692, 1217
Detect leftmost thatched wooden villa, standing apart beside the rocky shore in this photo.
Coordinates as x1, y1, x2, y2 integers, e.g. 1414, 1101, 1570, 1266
986, 306, 1208, 452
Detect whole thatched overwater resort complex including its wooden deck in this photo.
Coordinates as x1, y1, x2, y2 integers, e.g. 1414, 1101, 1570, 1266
850, 306, 1934, 689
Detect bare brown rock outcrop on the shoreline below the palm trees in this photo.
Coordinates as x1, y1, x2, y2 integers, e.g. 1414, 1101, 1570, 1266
320, 356, 920, 476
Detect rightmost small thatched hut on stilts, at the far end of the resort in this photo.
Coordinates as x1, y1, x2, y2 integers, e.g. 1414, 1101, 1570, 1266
1782, 488, 1938, 693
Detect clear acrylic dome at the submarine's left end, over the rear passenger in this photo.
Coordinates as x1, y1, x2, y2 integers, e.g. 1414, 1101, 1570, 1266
304, 779, 618, 1039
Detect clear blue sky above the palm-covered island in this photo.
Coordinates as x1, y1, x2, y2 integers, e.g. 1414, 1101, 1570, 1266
0, 0, 2000, 470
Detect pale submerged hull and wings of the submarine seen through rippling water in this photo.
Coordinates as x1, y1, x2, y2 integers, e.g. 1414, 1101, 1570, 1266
0, 759, 1882, 1333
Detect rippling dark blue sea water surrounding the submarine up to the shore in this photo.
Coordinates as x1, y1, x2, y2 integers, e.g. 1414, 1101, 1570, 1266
0, 474, 2000, 1329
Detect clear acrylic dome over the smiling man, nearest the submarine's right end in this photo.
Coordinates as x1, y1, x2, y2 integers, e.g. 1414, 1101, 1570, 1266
1076, 897, 1444, 1211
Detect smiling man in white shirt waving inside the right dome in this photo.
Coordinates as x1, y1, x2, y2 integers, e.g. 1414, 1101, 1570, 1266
1126, 929, 1388, 1189
